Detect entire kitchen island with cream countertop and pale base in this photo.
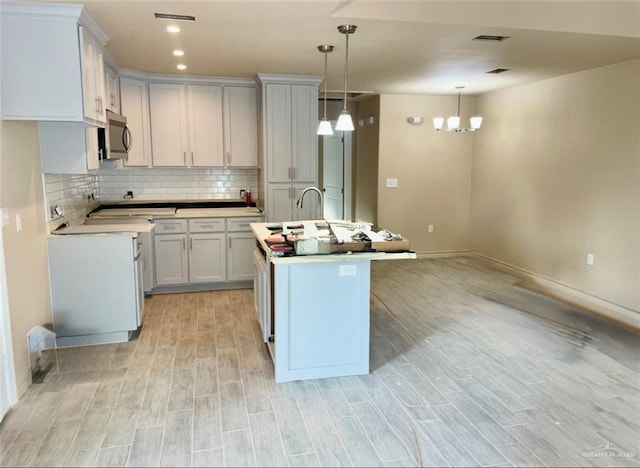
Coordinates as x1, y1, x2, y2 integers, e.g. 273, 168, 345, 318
250, 221, 416, 383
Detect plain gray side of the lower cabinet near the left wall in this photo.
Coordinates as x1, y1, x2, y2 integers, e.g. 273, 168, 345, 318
47, 233, 144, 347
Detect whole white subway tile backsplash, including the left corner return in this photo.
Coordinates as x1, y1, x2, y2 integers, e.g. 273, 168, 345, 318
43, 168, 259, 228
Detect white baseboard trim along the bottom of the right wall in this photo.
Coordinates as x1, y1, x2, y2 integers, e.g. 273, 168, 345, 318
470, 252, 640, 334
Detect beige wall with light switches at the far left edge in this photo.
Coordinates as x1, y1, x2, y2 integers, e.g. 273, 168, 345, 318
0, 121, 52, 396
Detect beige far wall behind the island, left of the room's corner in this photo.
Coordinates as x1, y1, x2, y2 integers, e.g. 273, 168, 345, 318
378, 95, 475, 253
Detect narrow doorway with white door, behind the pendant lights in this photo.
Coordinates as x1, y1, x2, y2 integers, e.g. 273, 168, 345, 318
319, 130, 352, 220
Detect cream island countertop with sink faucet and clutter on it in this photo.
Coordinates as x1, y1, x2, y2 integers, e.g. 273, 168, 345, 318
249, 220, 417, 264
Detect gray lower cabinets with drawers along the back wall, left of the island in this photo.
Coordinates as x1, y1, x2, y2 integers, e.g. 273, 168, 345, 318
155, 218, 255, 287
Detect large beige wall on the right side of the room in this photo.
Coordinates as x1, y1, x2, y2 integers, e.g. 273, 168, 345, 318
471, 60, 640, 311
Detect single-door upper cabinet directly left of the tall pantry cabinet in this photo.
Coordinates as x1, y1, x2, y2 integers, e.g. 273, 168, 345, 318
224, 86, 258, 167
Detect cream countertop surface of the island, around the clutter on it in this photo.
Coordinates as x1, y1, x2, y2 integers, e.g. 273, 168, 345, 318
249, 220, 417, 264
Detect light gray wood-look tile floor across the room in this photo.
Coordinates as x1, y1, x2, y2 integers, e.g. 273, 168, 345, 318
0, 258, 640, 466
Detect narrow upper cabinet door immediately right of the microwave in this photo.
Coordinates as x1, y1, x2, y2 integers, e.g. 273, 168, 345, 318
120, 77, 151, 167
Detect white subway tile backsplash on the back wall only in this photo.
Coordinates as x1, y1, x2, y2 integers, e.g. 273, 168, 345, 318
97, 167, 258, 200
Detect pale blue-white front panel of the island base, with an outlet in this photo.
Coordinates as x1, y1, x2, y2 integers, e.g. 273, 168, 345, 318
272, 259, 371, 382
